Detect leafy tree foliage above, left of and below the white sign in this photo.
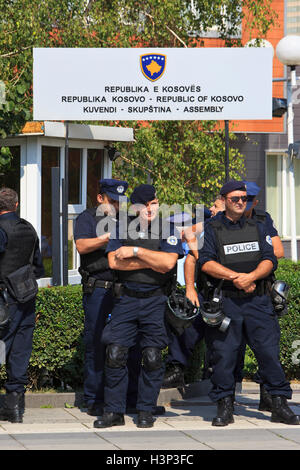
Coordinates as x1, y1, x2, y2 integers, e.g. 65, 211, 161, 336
0, 0, 276, 195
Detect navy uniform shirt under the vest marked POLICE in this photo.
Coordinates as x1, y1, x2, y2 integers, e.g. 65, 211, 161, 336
198, 212, 277, 271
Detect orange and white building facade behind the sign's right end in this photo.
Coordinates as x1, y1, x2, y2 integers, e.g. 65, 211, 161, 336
199, 0, 300, 260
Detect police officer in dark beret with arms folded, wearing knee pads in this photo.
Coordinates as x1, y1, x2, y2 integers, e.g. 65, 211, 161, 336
94, 184, 183, 428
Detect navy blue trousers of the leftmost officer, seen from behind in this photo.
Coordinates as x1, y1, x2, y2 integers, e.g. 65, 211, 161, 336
2, 298, 35, 393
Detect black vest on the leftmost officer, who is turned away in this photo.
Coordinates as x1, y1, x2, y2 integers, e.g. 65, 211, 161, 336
0, 217, 37, 280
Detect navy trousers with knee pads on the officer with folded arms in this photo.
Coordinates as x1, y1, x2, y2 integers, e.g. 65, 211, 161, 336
103, 296, 168, 413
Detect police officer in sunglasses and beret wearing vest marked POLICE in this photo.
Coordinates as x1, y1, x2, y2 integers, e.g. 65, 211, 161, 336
198, 181, 300, 426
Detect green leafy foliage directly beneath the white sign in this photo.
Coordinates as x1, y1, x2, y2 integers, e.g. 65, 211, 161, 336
114, 121, 244, 205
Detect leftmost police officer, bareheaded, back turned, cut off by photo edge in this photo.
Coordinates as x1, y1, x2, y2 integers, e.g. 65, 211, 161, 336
0, 188, 44, 423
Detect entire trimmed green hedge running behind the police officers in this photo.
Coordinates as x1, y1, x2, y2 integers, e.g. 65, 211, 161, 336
0, 260, 300, 390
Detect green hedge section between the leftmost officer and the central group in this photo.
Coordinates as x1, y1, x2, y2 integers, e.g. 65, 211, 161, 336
0, 285, 84, 390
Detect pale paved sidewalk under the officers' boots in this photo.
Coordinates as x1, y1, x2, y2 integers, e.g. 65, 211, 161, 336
0, 383, 300, 450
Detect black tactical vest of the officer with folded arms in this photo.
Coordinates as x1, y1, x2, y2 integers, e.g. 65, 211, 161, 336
118, 218, 177, 286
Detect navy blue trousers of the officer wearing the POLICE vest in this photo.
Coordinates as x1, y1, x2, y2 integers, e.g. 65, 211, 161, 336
206, 295, 292, 401
